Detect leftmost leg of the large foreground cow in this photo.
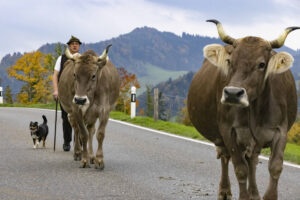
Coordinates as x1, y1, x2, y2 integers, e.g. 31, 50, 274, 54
216, 146, 232, 200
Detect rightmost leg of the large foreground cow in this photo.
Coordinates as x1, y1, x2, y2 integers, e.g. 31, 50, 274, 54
264, 134, 286, 200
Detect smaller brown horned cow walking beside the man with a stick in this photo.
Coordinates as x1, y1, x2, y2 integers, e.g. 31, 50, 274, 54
58, 45, 120, 169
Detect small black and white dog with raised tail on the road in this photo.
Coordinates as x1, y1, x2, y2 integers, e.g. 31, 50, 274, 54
29, 115, 48, 148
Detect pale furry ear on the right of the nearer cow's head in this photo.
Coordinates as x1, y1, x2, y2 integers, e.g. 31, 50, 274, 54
266, 52, 294, 76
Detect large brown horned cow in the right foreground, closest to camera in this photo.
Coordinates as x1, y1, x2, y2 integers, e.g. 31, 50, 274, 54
188, 20, 300, 200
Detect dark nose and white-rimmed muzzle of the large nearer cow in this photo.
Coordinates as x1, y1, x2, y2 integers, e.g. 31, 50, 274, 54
221, 86, 249, 107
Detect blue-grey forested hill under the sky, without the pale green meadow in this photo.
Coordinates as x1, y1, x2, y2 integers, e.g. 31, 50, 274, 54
39, 27, 221, 75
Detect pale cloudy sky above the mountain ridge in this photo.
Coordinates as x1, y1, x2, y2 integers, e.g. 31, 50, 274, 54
0, 0, 300, 59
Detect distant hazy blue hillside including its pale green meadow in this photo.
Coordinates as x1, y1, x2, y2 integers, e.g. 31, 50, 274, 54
0, 27, 300, 97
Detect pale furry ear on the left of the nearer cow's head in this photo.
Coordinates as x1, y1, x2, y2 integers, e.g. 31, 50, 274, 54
203, 44, 230, 72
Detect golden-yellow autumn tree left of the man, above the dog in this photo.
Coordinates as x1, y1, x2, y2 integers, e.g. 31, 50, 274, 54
7, 51, 54, 104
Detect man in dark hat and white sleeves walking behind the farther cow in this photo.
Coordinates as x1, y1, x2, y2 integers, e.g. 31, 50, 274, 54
53, 36, 81, 151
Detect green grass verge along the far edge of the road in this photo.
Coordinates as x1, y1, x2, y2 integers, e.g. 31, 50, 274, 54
0, 103, 300, 164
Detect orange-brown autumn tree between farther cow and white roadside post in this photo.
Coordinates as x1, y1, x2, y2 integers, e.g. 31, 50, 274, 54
116, 68, 141, 114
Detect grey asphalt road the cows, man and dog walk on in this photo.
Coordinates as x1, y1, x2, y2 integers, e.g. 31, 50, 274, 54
0, 108, 300, 200
